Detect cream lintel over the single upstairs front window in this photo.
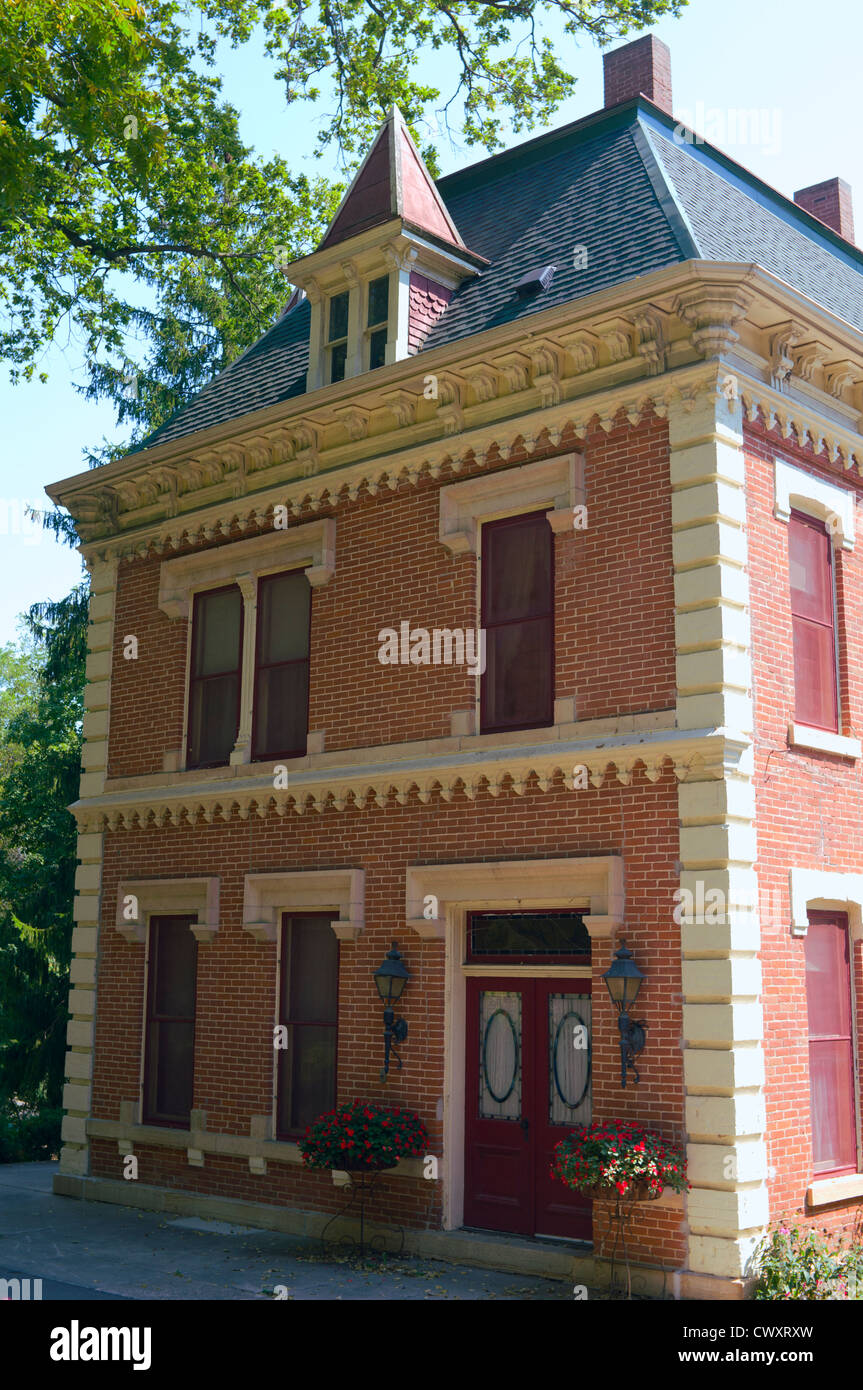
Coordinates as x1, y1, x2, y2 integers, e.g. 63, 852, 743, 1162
438, 453, 584, 555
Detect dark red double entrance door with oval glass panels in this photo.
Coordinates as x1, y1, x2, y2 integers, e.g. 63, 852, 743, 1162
464, 976, 592, 1240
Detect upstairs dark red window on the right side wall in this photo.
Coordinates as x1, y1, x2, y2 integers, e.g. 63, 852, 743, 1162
788, 512, 839, 733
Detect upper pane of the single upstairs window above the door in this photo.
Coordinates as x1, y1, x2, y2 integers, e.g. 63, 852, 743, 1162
482, 517, 552, 627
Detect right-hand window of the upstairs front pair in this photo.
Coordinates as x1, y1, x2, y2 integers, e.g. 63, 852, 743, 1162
252, 570, 311, 759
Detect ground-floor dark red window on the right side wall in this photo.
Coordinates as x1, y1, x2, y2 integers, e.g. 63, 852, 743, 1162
806, 912, 857, 1175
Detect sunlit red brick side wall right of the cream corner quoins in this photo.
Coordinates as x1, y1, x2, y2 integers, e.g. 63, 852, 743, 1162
745, 427, 863, 1245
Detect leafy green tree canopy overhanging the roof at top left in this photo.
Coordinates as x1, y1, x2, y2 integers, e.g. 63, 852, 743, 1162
0, 0, 685, 439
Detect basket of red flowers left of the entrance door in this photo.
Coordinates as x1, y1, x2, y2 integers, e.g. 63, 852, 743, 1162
299, 1101, 428, 1173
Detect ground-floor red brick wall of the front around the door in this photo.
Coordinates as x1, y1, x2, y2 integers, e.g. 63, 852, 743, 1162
92, 771, 684, 1266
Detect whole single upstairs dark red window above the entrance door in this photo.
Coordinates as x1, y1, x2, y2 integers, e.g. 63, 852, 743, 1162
481, 512, 554, 734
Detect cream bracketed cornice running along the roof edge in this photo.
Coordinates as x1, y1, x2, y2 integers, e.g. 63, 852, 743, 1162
50, 261, 863, 556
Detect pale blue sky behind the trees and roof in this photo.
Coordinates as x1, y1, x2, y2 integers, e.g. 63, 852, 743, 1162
0, 0, 863, 644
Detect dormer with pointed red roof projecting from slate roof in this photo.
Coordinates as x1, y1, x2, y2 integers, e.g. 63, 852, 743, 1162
285, 106, 488, 391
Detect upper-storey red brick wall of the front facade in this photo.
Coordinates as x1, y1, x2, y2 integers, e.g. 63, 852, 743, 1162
108, 416, 675, 777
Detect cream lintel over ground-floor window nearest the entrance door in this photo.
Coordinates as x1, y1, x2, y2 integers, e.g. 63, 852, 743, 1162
243, 869, 365, 942
